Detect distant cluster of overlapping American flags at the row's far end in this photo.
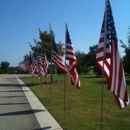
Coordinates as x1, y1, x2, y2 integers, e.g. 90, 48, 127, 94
19, 44, 49, 83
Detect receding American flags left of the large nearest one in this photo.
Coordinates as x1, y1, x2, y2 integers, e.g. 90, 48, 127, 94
19, 25, 81, 89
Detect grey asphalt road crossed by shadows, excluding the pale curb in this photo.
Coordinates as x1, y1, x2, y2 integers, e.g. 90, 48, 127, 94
0, 75, 41, 130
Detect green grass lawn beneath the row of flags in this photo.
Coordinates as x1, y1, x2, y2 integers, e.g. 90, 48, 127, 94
21, 75, 130, 130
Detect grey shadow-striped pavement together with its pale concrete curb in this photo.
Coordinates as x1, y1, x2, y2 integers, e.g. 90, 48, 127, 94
0, 75, 62, 130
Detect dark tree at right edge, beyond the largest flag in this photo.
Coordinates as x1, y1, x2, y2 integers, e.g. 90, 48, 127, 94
120, 27, 130, 74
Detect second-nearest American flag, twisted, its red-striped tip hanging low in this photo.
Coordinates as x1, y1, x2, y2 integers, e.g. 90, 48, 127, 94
66, 25, 81, 88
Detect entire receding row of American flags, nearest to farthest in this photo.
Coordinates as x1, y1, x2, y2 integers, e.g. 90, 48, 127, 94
19, 0, 130, 108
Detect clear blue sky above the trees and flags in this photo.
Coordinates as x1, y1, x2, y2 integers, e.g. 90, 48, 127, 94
0, 0, 130, 66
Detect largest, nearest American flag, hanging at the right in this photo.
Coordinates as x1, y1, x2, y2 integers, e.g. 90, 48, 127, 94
96, 0, 129, 108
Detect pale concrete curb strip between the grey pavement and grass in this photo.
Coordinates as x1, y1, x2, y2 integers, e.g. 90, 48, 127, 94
17, 79, 63, 130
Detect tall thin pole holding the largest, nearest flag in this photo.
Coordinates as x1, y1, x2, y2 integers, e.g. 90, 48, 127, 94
100, 0, 107, 130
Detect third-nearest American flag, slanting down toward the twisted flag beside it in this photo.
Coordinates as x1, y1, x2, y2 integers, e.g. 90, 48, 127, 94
52, 36, 70, 75
